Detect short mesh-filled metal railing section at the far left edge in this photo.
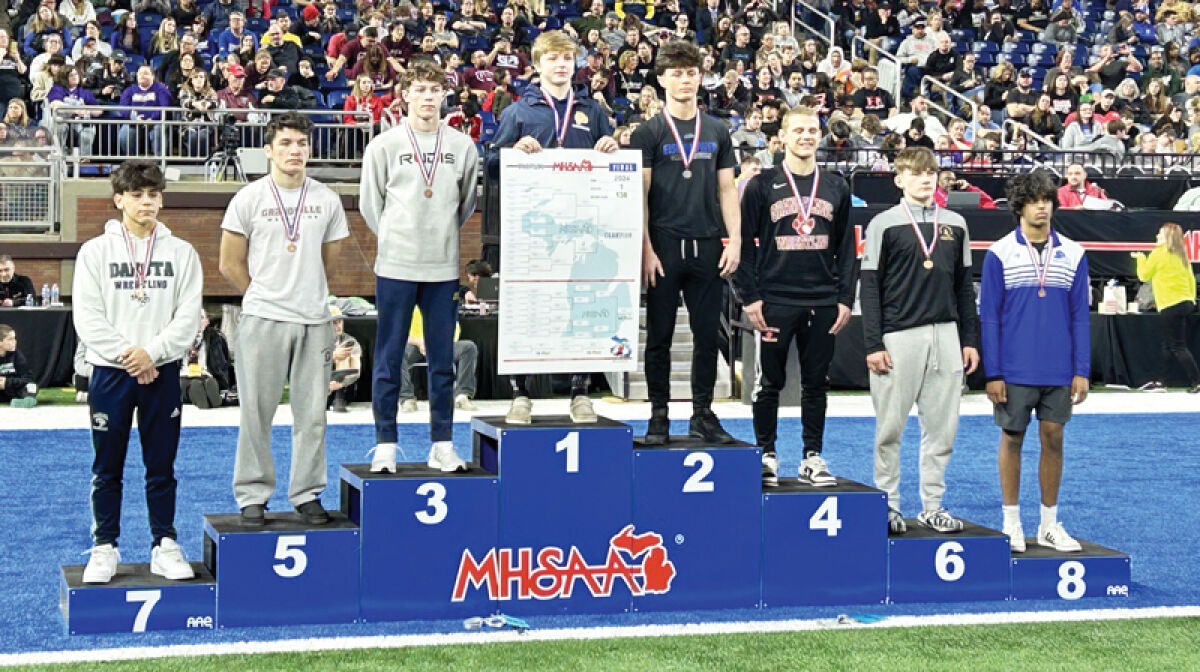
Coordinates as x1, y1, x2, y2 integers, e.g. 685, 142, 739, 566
0, 145, 62, 234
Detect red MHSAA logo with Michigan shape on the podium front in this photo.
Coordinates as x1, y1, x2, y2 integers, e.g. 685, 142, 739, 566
450, 526, 676, 602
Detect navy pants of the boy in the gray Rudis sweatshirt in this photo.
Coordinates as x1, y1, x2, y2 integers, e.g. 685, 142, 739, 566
371, 277, 458, 443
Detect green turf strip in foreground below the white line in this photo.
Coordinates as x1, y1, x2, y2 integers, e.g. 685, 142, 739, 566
9, 618, 1200, 672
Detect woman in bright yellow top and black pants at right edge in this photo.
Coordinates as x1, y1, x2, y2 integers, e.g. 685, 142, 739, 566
1132, 222, 1200, 394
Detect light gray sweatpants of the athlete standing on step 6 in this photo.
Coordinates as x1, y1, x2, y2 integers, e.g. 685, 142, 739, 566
870, 322, 962, 511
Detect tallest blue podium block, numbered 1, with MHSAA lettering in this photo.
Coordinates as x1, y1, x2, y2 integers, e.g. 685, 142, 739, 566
460, 415, 642, 616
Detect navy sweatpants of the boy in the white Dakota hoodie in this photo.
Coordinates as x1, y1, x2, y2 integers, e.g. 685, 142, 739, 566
88, 361, 181, 546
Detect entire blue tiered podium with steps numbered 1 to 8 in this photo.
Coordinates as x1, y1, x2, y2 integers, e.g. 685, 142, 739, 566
60, 416, 1132, 634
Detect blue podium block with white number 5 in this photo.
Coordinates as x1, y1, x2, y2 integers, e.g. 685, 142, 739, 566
204, 511, 359, 628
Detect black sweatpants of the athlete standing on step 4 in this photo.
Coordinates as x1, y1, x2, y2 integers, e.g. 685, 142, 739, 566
754, 301, 838, 456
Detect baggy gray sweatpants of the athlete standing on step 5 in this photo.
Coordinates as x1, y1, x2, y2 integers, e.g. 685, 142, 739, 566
233, 316, 334, 509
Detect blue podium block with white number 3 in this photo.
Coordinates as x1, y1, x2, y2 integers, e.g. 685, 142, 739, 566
341, 463, 499, 622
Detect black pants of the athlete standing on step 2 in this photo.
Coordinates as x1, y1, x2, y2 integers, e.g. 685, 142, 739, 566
646, 232, 722, 410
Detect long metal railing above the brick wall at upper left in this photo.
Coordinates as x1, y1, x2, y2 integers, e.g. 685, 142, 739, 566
50, 106, 376, 179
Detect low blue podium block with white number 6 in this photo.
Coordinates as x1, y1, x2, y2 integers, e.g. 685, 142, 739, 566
880, 516, 1012, 602
